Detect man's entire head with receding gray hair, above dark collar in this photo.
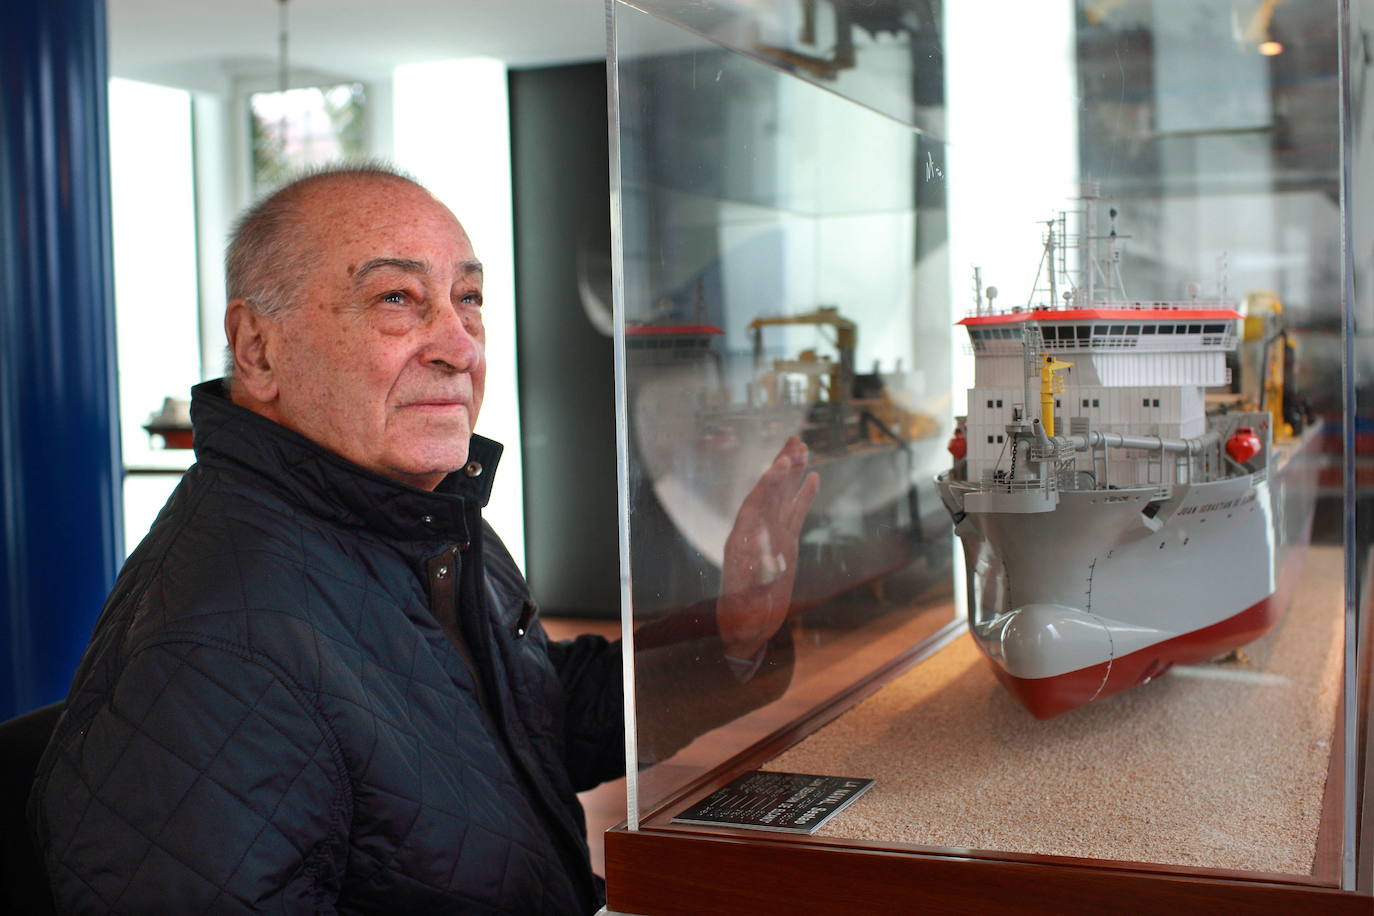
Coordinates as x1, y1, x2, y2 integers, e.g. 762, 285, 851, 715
224, 169, 486, 489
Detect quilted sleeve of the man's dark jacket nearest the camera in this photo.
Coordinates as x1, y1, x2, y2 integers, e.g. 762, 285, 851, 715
29, 637, 350, 913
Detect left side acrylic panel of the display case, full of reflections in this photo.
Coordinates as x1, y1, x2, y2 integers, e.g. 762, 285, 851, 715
614, 5, 954, 809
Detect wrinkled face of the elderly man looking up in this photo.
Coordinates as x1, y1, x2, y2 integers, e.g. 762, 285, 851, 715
267, 181, 486, 489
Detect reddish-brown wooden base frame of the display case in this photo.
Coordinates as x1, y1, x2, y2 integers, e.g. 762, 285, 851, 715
606, 549, 1374, 916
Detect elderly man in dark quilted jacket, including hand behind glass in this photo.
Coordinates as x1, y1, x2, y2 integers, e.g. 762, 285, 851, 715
30, 168, 816, 913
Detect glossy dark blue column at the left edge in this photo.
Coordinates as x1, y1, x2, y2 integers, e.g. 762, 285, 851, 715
0, 0, 122, 718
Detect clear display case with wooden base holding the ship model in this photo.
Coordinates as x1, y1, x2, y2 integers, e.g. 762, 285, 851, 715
606, 0, 1374, 915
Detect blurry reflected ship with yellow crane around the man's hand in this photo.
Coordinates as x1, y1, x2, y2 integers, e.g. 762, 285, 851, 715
625, 308, 937, 607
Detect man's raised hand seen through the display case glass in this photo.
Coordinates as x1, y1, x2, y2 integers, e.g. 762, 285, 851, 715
716, 435, 820, 659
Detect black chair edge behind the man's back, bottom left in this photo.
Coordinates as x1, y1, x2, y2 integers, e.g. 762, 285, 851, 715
0, 703, 63, 915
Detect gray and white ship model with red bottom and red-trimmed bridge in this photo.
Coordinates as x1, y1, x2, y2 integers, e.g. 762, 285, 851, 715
938, 184, 1315, 718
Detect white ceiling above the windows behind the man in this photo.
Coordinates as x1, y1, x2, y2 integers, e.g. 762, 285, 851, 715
115, 0, 606, 91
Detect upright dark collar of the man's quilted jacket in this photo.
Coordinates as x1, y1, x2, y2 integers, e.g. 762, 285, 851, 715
191, 379, 502, 540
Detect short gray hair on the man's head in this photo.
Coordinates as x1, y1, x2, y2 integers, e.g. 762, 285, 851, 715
224, 159, 425, 378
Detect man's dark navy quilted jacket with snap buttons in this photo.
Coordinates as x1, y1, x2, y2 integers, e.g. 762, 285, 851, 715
30, 382, 624, 913
